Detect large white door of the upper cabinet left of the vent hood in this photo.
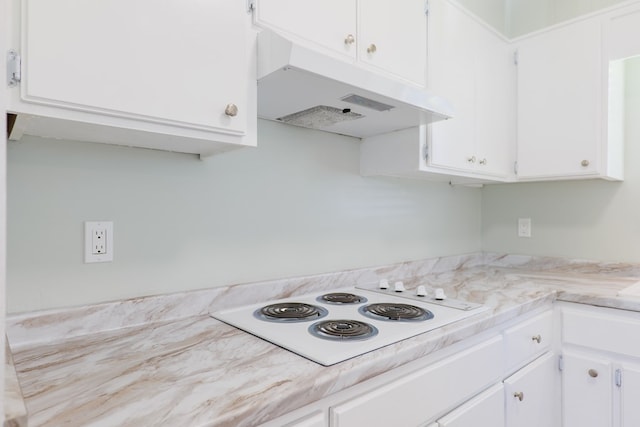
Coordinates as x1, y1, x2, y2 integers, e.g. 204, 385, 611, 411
21, 0, 250, 134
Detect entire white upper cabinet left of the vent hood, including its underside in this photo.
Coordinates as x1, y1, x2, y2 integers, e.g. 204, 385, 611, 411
9, 0, 256, 154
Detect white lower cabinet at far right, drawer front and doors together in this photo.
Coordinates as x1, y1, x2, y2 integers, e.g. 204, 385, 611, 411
559, 303, 640, 427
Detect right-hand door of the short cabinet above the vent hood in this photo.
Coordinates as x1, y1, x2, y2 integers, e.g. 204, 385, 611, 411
358, 0, 427, 86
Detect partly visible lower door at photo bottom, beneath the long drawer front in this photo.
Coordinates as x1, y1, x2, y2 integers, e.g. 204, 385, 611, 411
437, 384, 505, 427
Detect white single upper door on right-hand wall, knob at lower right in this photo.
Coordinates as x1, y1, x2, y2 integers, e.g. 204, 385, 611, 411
517, 18, 603, 179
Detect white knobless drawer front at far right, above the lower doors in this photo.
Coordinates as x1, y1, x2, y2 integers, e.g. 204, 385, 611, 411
562, 309, 640, 357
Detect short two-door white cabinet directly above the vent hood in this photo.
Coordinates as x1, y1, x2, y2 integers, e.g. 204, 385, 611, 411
255, 0, 427, 87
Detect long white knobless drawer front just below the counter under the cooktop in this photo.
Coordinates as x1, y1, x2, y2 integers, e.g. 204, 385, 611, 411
330, 336, 503, 427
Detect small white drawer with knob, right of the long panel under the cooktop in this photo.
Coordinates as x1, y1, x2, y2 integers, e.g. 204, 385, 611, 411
504, 311, 553, 371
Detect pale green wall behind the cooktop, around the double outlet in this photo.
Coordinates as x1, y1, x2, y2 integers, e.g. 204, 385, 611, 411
7, 121, 481, 312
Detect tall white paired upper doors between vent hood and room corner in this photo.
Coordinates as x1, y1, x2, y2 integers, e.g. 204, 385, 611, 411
428, 0, 516, 180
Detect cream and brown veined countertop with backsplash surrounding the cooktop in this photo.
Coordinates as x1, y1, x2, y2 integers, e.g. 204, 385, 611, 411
7, 254, 640, 427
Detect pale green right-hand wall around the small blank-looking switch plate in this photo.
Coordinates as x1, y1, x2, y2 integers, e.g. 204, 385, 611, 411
482, 58, 640, 262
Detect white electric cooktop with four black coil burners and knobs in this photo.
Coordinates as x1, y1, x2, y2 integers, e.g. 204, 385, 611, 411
211, 286, 486, 366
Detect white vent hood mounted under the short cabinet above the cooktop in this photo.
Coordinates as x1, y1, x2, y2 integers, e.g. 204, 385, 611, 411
258, 30, 453, 138
